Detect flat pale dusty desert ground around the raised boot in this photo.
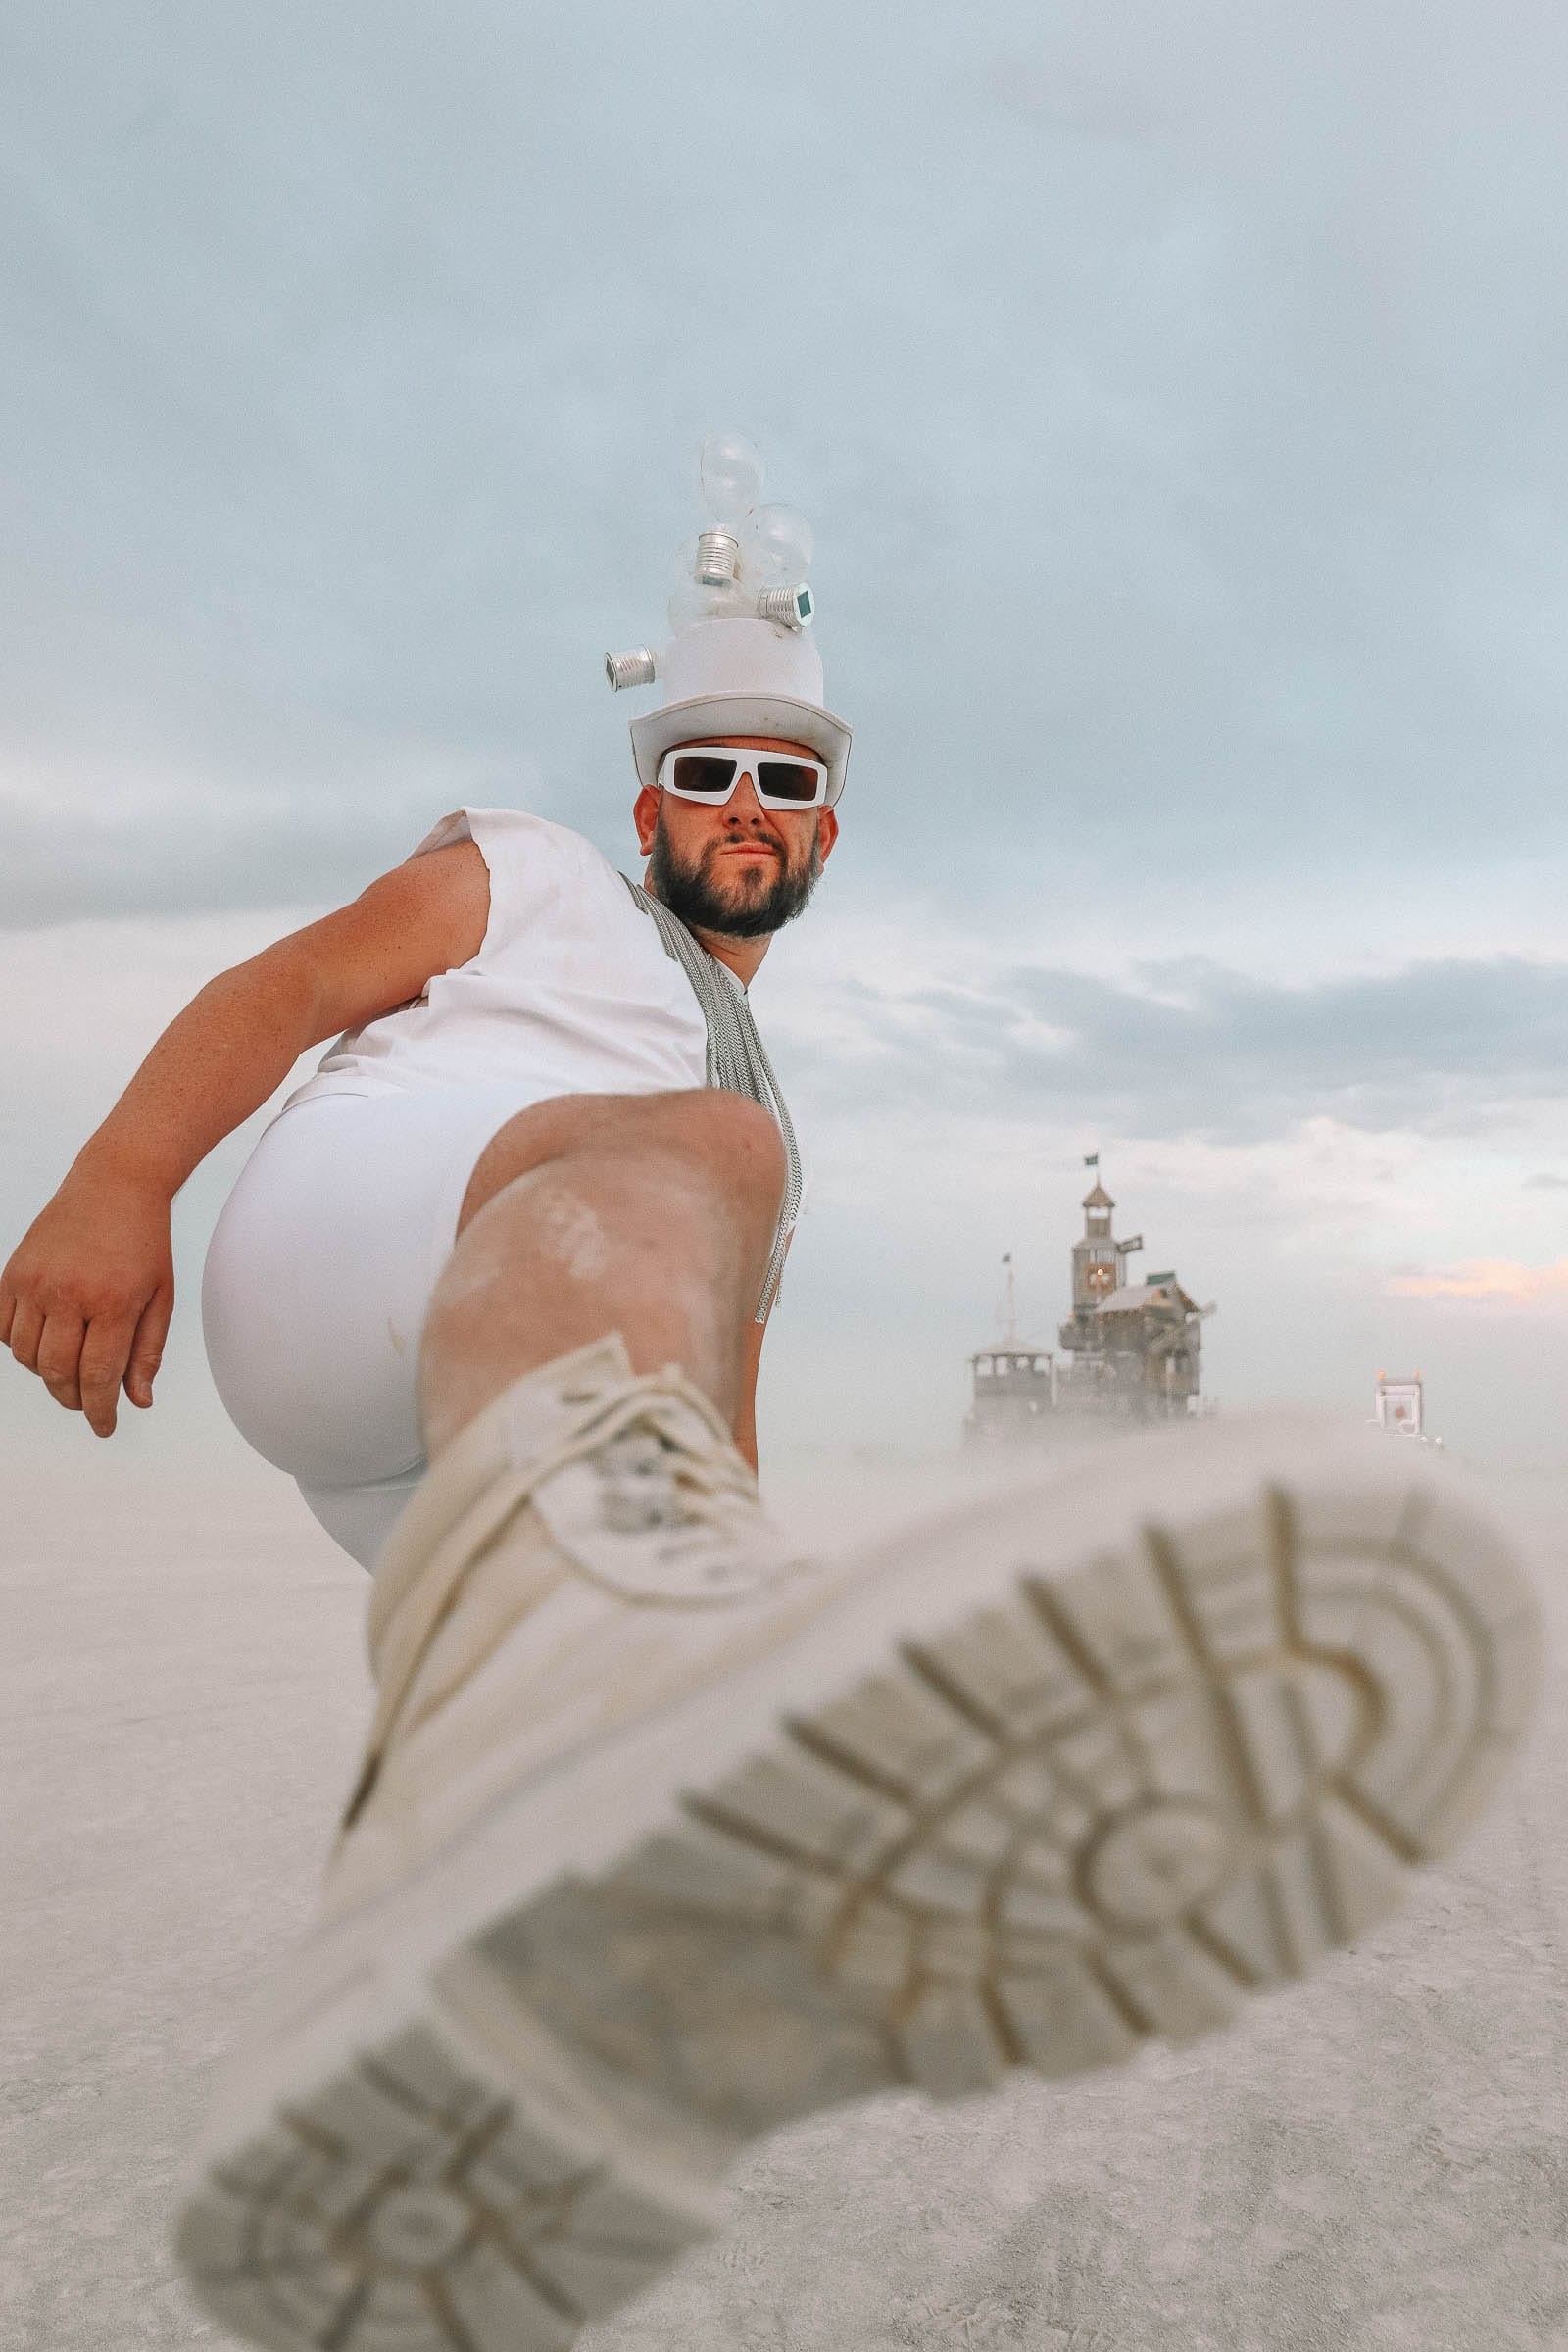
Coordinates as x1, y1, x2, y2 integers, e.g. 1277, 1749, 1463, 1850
0, 1456, 1568, 2352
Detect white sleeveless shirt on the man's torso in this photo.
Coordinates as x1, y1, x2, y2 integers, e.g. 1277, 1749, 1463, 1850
284, 809, 714, 1110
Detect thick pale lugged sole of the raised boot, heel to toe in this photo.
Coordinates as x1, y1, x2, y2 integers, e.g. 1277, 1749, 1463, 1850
178, 1433, 1540, 2352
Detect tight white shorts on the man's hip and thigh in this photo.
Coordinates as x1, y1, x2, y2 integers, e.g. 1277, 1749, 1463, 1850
202, 1082, 538, 1569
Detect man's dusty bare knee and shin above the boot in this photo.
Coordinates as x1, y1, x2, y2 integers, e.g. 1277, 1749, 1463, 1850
420, 1092, 785, 1456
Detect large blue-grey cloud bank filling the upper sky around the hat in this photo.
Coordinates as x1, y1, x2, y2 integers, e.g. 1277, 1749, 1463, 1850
0, 0, 1568, 931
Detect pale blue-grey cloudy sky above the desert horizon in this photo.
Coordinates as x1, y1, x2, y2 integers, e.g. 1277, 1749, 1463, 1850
0, 0, 1568, 1495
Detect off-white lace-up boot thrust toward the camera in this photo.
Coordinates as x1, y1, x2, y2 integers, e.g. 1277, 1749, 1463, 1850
178, 1341, 1540, 2352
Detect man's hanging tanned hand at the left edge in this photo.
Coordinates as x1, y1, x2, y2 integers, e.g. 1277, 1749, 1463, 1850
0, 1171, 174, 1437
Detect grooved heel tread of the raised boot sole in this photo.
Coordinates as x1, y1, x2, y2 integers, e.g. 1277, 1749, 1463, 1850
178, 2023, 710, 2352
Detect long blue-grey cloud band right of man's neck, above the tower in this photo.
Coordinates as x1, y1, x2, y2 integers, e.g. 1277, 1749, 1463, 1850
780, 943, 1568, 1143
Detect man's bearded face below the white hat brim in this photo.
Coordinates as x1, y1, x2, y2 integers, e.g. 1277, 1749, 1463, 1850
635, 736, 839, 939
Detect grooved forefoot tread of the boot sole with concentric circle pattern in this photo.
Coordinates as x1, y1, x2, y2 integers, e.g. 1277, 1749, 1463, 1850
585, 1484, 1535, 2129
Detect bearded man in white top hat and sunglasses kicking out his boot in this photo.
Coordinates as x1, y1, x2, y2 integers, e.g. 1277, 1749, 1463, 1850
0, 501, 1535, 2352
